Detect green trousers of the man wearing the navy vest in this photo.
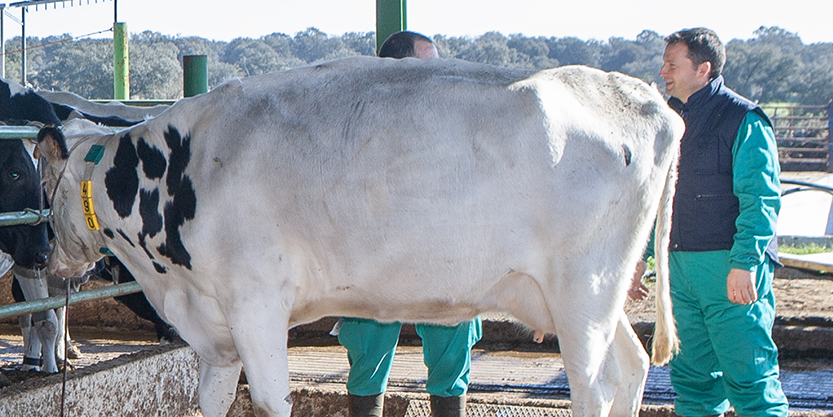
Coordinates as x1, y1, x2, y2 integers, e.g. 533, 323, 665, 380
669, 251, 788, 417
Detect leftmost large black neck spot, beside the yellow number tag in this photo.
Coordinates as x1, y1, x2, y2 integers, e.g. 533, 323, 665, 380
104, 134, 139, 218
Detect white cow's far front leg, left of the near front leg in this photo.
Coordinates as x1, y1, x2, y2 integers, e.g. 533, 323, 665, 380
199, 358, 243, 417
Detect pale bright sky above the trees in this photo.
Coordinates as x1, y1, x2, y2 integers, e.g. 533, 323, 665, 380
0, 0, 833, 44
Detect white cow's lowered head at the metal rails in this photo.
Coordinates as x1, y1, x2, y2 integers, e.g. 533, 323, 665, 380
37, 121, 109, 277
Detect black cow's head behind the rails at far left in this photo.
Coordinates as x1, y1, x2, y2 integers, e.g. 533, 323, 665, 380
0, 140, 49, 269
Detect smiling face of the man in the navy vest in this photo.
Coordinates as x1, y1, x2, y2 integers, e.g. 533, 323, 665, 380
659, 43, 711, 103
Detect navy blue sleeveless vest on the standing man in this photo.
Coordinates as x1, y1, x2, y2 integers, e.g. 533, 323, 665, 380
668, 76, 778, 262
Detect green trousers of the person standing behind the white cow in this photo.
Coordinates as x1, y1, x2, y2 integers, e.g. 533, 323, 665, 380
338, 316, 483, 397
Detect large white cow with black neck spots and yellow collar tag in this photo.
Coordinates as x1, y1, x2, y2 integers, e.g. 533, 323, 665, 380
34, 58, 683, 416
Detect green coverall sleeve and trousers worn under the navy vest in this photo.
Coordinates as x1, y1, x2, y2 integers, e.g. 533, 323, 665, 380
669, 112, 788, 417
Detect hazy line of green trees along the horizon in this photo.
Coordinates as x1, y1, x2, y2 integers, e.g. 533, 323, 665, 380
6, 27, 833, 104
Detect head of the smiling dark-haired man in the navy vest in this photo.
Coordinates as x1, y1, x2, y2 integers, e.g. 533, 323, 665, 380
659, 28, 726, 102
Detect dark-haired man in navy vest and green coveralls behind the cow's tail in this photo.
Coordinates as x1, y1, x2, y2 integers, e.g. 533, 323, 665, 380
629, 28, 788, 417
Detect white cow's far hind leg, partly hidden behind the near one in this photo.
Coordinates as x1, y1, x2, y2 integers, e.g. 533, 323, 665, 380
610, 310, 650, 416
